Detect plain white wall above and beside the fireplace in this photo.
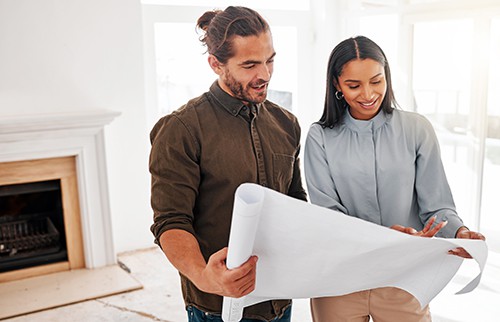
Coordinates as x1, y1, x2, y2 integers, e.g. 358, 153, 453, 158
0, 0, 152, 252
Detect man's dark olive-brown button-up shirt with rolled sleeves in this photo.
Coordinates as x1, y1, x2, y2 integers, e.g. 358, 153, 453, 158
150, 82, 306, 321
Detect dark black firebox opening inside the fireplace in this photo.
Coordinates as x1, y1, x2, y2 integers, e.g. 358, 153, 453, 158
0, 180, 68, 273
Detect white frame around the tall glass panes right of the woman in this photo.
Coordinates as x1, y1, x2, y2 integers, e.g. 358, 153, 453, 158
350, 0, 500, 252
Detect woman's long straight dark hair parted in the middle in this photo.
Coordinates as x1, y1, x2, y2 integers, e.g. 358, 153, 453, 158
317, 36, 398, 128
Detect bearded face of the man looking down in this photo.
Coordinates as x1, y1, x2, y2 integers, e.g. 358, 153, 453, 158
211, 32, 276, 103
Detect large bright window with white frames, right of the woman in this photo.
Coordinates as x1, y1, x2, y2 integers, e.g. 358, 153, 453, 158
360, 0, 500, 252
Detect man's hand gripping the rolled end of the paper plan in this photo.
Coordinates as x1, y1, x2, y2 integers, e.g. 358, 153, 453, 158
193, 247, 257, 298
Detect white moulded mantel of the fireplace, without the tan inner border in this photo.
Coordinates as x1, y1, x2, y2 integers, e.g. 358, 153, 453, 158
0, 110, 120, 268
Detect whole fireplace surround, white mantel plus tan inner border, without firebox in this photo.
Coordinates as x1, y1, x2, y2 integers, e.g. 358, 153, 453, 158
0, 110, 119, 282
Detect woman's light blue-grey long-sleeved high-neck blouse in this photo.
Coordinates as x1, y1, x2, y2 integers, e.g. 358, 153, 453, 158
304, 110, 463, 237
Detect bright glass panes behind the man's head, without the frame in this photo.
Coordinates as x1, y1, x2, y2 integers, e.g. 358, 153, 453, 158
155, 23, 298, 115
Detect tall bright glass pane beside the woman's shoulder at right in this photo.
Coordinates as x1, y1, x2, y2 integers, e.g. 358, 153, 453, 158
412, 19, 478, 229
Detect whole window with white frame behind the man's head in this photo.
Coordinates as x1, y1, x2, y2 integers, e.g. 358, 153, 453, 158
143, 0, 312, 127
